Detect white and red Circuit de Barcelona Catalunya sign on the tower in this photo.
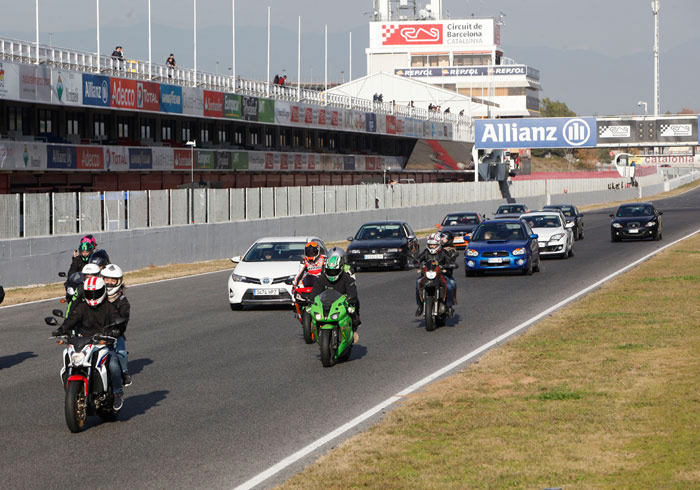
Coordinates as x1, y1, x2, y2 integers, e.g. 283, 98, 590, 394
369, 19, 500, 49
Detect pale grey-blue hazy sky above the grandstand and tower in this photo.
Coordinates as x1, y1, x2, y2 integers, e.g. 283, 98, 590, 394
0, 0, 700, 114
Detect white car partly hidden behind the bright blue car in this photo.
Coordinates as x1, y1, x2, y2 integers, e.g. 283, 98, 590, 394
520, 211, 575, 259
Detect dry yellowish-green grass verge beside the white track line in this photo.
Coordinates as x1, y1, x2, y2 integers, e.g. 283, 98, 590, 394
281, 232, 700, 489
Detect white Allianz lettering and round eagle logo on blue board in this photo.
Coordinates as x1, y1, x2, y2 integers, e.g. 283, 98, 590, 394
481, 119, 591, 146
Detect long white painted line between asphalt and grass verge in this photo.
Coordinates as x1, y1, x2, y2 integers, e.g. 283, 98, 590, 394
234, 230, 700, 490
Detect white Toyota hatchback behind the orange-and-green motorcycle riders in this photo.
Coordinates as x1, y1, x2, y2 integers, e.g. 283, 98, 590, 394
228, 237, 328, 310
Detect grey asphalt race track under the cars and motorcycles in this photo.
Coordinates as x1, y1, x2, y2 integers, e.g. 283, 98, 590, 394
0, 186, 700, 489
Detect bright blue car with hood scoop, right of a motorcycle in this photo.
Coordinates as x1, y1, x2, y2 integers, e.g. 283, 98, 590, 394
464, 218, 540, 277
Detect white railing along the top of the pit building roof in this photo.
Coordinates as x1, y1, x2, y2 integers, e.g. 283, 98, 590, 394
0, 38, 473, 141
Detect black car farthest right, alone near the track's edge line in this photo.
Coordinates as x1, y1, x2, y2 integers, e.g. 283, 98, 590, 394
610, 202, 664, 242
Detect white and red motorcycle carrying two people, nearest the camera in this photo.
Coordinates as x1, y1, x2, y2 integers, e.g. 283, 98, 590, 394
45, 310, 124, 433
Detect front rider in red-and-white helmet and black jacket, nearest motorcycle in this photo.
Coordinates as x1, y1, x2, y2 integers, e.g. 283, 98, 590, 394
54, 277, 124, 410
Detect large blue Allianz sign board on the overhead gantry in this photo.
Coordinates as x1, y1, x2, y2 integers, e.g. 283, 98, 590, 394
474, 117, 598, 149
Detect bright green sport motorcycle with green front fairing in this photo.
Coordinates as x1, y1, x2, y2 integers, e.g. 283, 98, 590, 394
309, 289, 353, 367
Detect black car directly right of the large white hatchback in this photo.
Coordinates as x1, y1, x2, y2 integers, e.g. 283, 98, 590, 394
346, 221, 418, 270
